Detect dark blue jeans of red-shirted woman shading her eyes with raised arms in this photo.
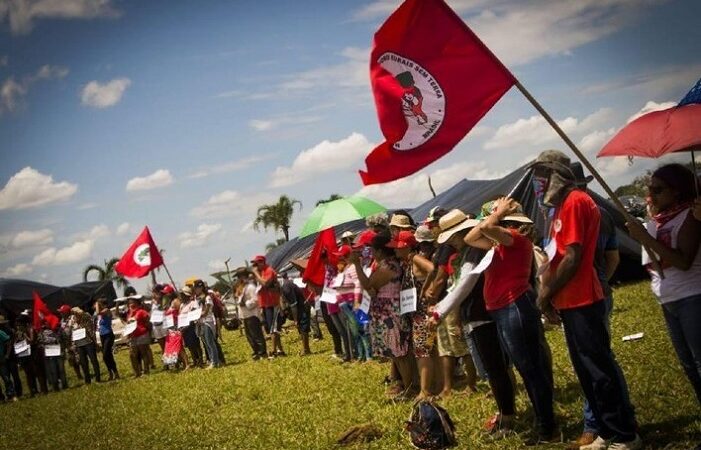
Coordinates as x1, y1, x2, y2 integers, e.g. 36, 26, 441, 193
489, 291, 555, 435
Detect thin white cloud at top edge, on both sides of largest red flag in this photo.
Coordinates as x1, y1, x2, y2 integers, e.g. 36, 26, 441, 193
353, 0, 666, 65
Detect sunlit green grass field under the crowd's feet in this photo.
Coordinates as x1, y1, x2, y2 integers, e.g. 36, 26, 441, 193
0, 282, 701, 450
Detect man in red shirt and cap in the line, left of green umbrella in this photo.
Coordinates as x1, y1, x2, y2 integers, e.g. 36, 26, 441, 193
251, 255, 285, 356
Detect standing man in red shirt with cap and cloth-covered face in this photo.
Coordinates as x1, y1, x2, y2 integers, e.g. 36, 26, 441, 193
533, 150, 642, 450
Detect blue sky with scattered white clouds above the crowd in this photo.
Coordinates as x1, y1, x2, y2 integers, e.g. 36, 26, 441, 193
0, 0, 701, 287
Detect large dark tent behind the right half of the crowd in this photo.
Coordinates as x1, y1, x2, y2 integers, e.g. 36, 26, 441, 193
268, 165, 647, 280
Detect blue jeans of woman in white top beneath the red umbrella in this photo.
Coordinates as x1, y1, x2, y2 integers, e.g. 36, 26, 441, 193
662, 295, 701, 403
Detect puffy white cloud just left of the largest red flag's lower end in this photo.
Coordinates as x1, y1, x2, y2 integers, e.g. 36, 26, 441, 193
270, 132, 373, 187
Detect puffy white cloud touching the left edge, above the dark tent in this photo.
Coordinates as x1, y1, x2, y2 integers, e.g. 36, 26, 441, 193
0, 167, 78, 210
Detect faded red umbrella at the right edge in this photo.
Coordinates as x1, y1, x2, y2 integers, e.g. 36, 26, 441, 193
597, 104, 701, 158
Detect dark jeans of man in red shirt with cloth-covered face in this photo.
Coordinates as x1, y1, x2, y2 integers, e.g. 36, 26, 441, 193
560, 300, 636, 442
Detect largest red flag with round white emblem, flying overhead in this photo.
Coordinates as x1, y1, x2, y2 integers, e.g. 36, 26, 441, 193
360, 0, 516, 185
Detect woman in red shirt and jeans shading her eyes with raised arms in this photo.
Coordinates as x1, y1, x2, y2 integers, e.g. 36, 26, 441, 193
465, 197, 560, 443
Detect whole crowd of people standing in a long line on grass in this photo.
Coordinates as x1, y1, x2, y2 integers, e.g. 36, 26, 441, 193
0, 150, 701, 450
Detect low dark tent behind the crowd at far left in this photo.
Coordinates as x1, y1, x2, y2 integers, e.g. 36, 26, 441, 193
0, 278, 117, 317
